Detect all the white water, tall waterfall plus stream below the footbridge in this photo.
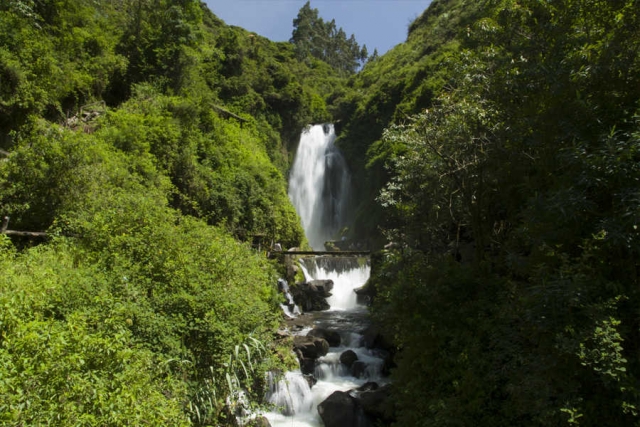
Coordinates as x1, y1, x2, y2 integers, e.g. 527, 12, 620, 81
266, 125, 384, 427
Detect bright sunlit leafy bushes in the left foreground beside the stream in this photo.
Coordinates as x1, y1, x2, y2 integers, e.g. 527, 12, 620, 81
0, 114, 284, 425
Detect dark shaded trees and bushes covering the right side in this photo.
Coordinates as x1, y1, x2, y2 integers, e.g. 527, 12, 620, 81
356, 0, 640, 426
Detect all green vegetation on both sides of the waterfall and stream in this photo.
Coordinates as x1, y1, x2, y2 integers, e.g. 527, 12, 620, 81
0, 0, 640, 427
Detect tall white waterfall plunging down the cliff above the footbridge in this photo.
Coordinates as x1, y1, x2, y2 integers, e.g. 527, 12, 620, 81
289, 124, 351, 250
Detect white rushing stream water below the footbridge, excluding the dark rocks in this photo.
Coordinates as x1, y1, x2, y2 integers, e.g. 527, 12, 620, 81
266, 257, 385, 427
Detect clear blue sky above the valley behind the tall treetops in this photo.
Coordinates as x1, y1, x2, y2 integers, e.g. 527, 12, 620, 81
205, 0, 431, 55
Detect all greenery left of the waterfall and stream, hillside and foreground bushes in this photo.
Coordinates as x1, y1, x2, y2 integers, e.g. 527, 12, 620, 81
0, 0, 340, 425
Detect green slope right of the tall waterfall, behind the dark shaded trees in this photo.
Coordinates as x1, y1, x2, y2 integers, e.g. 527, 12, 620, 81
332, 0, 480, 245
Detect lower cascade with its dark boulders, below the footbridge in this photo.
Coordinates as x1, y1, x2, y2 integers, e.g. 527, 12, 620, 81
265, 256, 389, 427
